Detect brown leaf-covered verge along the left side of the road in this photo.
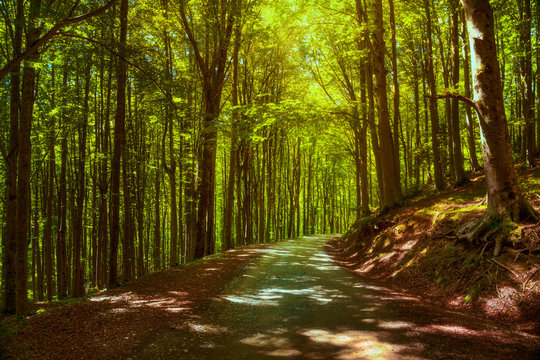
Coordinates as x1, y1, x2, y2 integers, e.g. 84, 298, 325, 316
0, 245, 267, 360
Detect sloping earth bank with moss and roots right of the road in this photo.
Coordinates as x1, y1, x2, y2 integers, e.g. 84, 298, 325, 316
330, 163, 540, 335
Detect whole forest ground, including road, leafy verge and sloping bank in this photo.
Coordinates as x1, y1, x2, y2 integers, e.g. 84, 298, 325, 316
0, 168, 540, 359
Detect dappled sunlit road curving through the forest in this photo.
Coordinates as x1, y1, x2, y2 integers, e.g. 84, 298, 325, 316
130, 235, 540, 360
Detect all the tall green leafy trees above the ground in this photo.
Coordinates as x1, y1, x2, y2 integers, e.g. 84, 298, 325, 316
0, 0, 540, 348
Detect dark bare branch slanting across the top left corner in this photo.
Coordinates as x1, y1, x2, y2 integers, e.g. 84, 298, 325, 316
0, 0, 117, 81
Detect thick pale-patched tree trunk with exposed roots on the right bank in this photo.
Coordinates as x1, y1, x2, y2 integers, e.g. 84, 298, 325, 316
461, 0, 536, 256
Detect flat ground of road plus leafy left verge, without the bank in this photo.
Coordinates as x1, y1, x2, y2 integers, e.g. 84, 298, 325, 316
3, 235, 540, 360
